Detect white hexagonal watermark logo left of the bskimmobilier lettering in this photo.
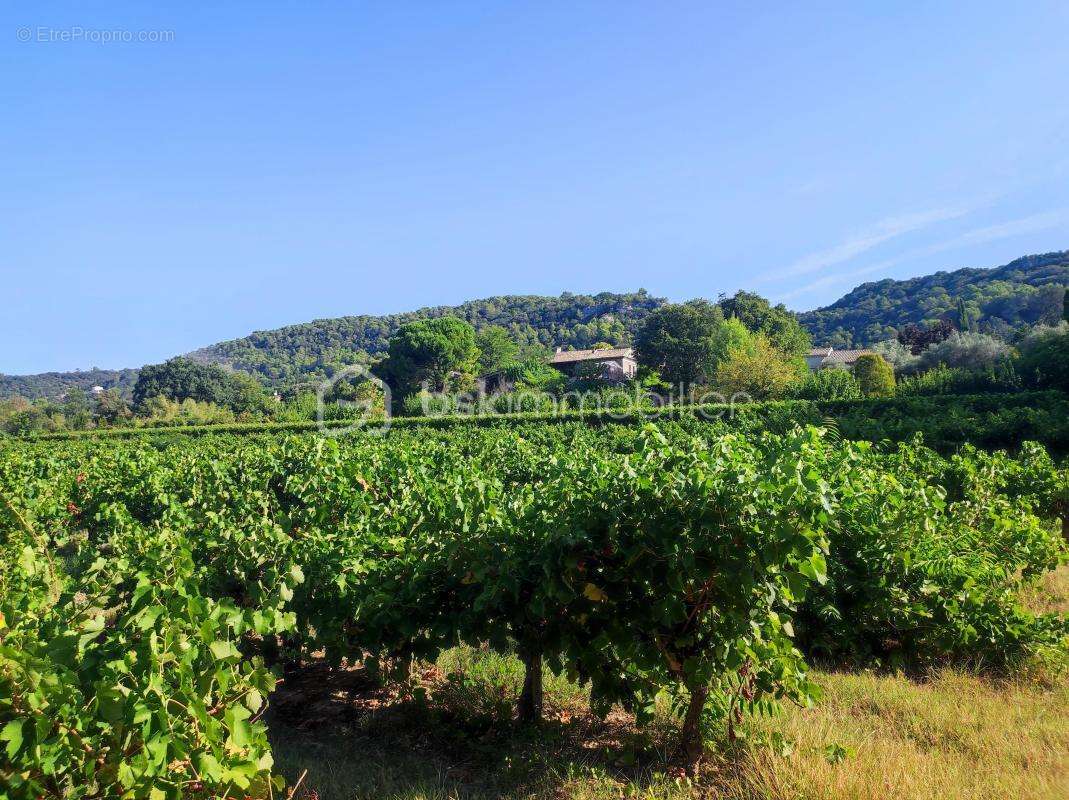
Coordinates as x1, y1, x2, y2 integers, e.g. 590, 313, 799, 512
315, 364, 393, 436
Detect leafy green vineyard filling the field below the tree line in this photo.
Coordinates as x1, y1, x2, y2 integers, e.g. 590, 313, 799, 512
0, 410, 1069, 800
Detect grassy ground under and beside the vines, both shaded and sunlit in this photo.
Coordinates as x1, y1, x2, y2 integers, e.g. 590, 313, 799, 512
270, 568, 1069, 800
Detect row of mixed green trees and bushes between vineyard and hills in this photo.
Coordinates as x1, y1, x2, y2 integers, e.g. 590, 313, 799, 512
0, 292, 1069, 435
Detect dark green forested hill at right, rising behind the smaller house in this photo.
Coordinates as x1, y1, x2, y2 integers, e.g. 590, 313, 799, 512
799, 250, 1069, 347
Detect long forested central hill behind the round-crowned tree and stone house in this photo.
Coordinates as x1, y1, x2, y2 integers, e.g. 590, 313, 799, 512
189, 290, 665, 384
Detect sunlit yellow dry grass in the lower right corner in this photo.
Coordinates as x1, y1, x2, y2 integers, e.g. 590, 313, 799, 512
723, 671, 1069, 800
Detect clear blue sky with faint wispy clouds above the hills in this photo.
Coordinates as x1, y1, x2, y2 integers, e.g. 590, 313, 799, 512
0, 0, 1069, 373
